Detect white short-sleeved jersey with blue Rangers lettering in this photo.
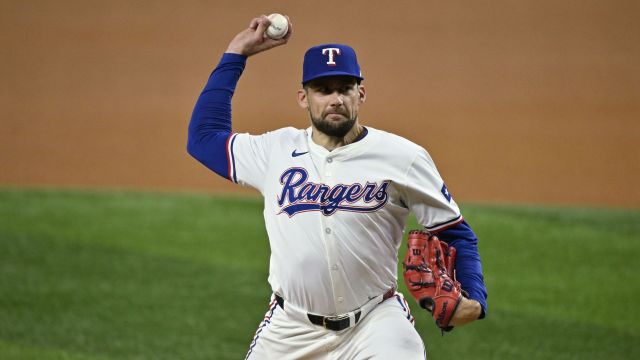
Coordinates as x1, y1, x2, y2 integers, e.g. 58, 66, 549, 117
227, 127, 462, 315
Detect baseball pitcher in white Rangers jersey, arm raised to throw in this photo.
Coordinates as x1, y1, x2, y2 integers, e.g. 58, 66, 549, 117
187, 16, 487, 360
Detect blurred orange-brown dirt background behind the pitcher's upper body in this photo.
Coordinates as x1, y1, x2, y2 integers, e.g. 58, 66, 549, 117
0, 0, 640, 207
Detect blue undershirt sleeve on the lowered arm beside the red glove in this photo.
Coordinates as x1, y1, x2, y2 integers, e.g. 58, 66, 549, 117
435, 221, 487, 319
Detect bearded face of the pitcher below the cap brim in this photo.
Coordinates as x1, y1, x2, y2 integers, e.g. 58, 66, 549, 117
298, 76, 365, 137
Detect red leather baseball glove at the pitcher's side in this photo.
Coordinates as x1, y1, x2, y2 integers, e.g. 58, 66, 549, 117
403, 230, 462, 331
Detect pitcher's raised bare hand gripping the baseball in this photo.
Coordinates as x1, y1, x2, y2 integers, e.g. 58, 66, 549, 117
226, 15, 293, 56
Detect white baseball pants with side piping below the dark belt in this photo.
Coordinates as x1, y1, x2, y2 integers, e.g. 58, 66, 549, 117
245, 292, 426, 360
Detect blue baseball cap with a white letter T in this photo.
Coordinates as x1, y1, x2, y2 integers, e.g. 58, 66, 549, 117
302, 44, 364, 85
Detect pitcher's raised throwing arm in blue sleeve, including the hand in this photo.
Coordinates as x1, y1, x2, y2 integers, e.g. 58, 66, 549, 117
187, 15, 292, 181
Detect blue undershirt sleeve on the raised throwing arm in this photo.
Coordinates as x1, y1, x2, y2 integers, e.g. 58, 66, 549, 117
187, 53, 247, 180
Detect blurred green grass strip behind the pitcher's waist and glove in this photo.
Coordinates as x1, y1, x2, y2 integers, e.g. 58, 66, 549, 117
0, 189, 640, 360
